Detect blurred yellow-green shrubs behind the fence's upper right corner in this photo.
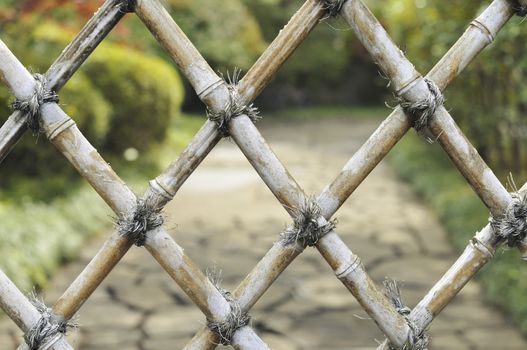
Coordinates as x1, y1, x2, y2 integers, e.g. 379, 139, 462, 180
379, 0, 527, 183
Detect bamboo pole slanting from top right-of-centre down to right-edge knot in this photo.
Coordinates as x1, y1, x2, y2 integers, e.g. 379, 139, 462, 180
342, 0, 512, 216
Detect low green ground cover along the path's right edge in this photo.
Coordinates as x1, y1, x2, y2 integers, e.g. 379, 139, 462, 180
388, 131, 527, 334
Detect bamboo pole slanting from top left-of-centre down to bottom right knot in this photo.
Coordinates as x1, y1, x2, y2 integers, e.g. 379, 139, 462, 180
136, 1, 416, 346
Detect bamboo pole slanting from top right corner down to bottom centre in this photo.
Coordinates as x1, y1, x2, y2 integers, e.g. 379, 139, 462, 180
188, 1, 511, 348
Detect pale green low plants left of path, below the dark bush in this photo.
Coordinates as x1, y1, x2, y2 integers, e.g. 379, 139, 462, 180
0, 188, 110, 291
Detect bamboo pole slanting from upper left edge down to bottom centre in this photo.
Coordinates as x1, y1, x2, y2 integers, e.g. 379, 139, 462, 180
0, 41, 267, 349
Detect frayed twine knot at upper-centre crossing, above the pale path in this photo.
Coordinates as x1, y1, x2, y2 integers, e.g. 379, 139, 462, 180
207, 69, 260, 136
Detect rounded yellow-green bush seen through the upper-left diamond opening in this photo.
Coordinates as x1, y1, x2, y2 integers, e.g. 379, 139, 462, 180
82, 45, 183, 153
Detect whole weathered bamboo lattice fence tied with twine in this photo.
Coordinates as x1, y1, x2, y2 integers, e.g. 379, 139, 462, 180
0, 0, 527, 350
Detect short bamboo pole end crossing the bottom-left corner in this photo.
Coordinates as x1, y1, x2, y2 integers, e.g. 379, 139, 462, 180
0, 270, 73, 350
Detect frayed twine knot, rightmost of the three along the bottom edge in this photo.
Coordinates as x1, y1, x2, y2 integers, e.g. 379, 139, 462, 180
383, 278, 429, 350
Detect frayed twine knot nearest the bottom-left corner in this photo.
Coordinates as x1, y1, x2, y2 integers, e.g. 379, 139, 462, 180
24, 297, 75, 350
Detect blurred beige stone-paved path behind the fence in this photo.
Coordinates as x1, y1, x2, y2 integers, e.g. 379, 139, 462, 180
0, 120, 527, 350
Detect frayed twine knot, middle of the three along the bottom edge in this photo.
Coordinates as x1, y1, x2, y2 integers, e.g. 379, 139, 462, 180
207, 273, 251, 345
